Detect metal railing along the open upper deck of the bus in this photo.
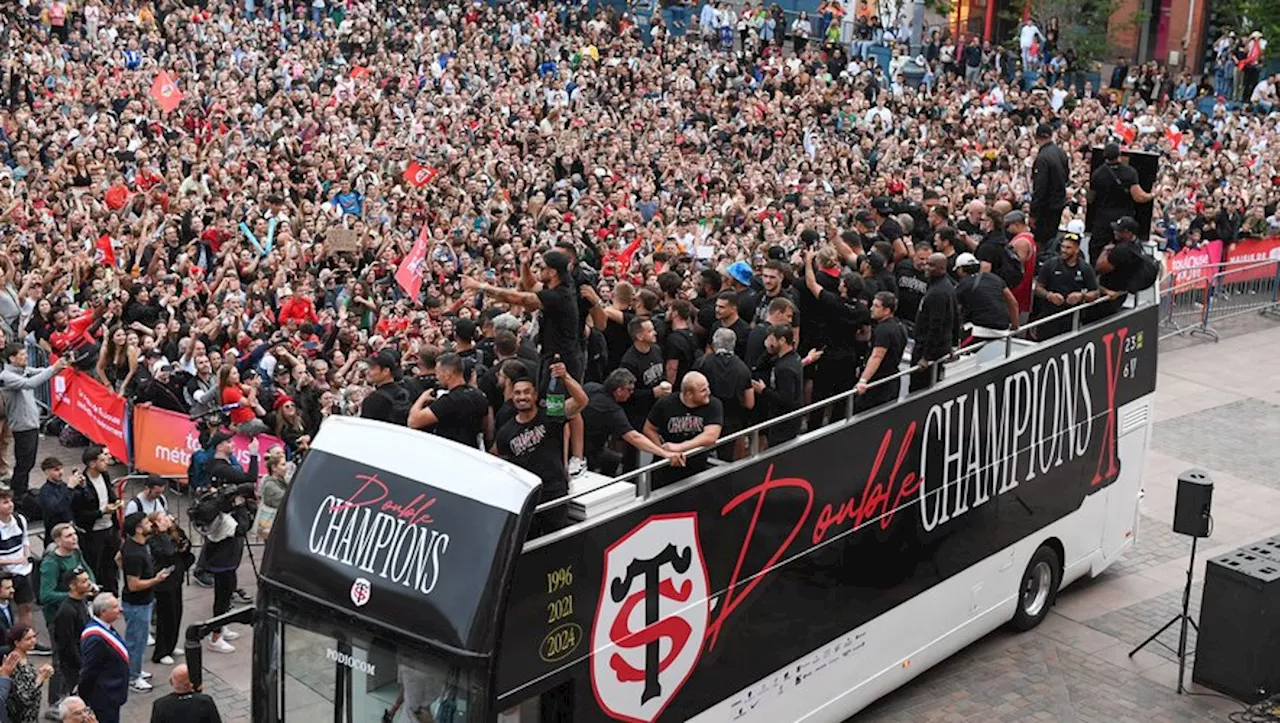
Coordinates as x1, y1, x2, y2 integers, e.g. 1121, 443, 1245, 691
529, 288, 1157, 529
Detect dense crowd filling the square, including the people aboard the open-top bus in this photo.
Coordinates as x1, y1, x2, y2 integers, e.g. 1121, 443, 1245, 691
0, 0, 1280, 720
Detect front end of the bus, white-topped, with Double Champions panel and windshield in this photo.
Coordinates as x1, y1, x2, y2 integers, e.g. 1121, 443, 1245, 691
253, 417, 539, 723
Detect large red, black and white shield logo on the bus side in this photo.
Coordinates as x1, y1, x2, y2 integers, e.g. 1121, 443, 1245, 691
591, 513, 710, 723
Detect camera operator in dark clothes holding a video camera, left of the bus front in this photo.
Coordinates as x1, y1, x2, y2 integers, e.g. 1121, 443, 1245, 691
191, 430, 259, 653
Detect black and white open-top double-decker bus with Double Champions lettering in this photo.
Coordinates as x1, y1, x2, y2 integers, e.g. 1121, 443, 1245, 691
189, 295, 1157, 723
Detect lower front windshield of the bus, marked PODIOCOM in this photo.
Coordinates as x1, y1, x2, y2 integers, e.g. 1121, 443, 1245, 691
259, 591, 485, 723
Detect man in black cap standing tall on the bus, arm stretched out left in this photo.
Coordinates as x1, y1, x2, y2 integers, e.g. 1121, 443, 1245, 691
462, 251, 586, 381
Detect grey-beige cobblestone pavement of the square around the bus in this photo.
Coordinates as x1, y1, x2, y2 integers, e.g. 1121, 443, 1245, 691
20, 326, 1280, 723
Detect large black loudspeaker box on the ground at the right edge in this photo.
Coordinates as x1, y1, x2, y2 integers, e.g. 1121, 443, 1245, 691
1192, 537, 1280, 704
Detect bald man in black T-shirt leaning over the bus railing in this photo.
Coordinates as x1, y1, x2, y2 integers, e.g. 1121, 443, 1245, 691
644, 371, 724, 489
